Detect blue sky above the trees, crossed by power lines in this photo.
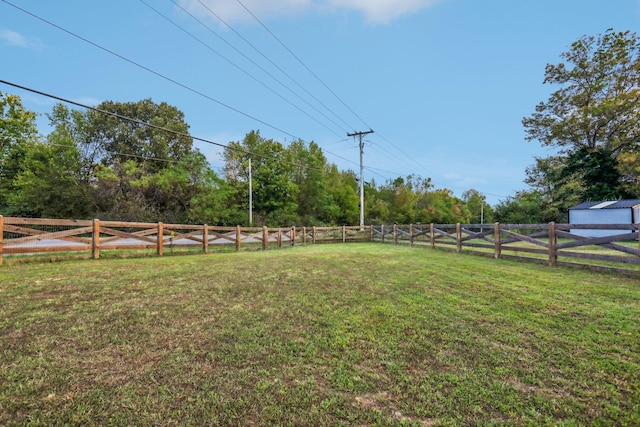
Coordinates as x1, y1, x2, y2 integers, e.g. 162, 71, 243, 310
0, 0, 640, 204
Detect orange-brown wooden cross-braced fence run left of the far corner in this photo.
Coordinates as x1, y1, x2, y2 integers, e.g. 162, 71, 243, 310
0, 216, 371, 264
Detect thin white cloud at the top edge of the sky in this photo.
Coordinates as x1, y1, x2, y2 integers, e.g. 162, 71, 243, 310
180, 0, 442, 24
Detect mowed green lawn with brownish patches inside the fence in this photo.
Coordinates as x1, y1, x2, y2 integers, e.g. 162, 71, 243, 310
0, 244, 640, 426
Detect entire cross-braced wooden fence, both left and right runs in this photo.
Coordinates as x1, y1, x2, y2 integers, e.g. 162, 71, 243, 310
0, 216, 640, 274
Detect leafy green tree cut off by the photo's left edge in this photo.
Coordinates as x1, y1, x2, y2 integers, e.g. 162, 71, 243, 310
0, 92, 38, 215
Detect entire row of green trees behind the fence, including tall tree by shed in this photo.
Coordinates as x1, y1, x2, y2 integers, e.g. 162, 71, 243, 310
0, 29, 640, 226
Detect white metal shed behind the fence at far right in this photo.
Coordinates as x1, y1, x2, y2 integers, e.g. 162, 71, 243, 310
569, 199, 640, 237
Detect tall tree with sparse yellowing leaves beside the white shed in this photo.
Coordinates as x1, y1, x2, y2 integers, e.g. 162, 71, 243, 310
522, 30, 640, 218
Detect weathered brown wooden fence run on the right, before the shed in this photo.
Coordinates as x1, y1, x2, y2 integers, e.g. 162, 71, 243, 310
372, 223, 640, 274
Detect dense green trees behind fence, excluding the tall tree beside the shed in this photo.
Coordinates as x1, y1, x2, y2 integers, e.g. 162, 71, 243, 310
0, 93, 492, 226
